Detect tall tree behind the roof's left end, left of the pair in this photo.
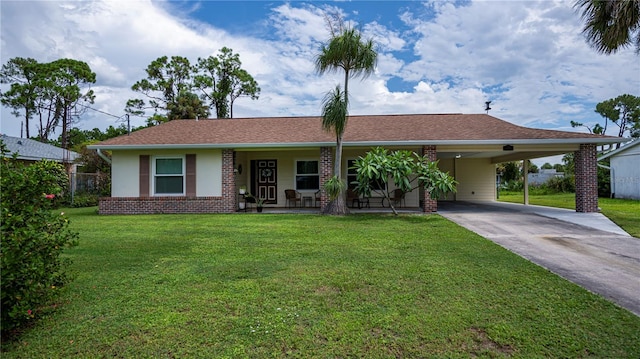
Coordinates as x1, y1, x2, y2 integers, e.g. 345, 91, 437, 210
125, 56, 209, 123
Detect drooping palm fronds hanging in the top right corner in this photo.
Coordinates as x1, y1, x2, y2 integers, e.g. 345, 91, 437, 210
575, 0, 640, 55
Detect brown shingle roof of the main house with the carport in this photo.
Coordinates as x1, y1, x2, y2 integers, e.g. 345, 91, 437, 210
91, 114, 619, 149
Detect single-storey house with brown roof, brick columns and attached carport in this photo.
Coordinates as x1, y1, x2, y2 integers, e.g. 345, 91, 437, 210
88, 114, 622, 214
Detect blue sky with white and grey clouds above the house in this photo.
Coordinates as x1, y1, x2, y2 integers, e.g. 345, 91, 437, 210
0, 0, 640, 163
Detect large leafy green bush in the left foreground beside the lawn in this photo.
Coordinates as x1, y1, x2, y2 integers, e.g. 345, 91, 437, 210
0, 149, 78, 336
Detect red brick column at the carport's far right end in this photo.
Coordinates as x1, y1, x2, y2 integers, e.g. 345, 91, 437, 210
574, 144, 598, 212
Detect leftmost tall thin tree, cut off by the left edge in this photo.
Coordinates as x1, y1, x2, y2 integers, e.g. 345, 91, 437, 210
0, 57, 39, 138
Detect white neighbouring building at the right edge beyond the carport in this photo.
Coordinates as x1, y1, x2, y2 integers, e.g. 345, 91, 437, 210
598, 139, 640, 200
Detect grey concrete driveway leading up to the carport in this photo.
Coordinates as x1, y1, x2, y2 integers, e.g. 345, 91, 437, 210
438, 202, 640, 316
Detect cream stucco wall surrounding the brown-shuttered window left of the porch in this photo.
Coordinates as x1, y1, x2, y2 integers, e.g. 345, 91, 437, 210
111, 150, 222, 197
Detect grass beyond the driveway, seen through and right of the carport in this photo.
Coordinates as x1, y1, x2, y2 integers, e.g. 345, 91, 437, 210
499, 191, 640, 238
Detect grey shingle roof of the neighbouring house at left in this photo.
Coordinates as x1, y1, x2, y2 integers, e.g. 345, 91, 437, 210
0, 135, 79, 162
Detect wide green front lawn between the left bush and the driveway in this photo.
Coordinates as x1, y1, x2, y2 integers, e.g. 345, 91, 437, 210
2, 209, 640, 359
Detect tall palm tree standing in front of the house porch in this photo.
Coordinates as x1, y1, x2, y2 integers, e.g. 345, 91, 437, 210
315, 21, 378, 214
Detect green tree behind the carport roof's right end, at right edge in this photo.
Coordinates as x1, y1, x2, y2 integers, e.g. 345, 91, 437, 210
571, 94, 640, 147
